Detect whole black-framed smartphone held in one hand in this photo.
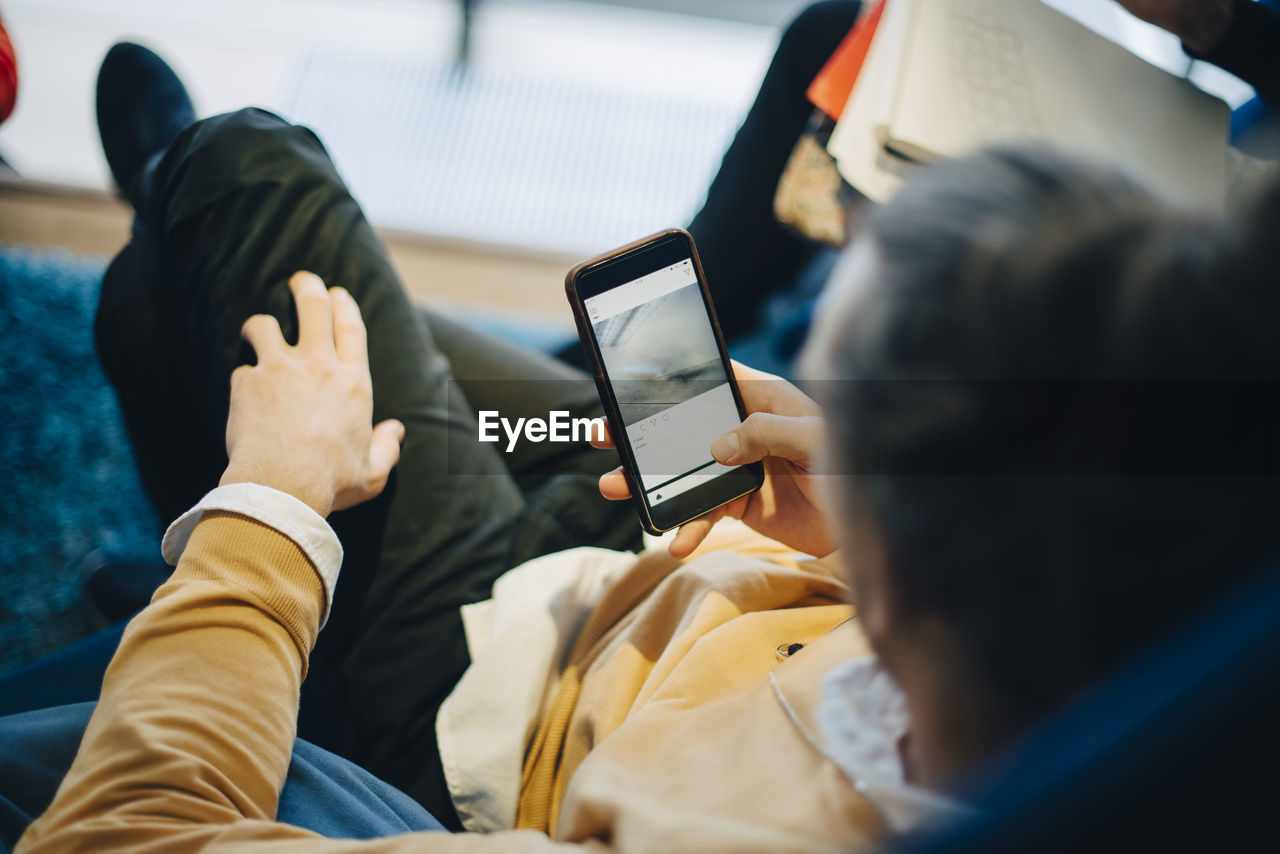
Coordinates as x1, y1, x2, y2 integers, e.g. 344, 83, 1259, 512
564, 228, 764, 534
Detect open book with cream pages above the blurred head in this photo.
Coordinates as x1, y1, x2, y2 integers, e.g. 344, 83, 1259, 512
828, 0, 1230, 210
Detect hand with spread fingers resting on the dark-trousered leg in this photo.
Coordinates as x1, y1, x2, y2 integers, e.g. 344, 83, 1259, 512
221, 273, 404, 516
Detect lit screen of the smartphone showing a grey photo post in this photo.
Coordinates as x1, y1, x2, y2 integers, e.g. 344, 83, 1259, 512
584, 259, 741, 506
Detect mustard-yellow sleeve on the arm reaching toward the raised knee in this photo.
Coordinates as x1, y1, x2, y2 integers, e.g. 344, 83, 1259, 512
18, 512, 594, 854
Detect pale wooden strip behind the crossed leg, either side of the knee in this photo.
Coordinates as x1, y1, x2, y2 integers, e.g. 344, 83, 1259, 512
0, 182, 575, 332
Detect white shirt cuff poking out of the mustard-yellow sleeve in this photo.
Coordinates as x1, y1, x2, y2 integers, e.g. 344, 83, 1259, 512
160, 483, 342, 627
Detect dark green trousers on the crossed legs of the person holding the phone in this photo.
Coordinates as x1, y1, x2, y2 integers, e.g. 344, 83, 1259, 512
95, 104, 640, 826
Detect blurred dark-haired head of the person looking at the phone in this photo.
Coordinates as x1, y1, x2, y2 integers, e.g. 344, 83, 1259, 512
815, 149, 1280, 729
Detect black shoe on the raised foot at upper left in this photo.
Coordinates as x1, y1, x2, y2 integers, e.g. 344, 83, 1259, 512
97, 42, 196, 196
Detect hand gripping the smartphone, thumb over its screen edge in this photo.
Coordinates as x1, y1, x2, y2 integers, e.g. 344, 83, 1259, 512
591, 362, 835, 557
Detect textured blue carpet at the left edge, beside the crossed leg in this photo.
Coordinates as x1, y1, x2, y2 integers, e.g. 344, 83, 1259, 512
0, 245, 161, 671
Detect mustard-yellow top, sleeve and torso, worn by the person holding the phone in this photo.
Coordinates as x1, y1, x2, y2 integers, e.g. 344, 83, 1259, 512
18, 511, 884, 853
